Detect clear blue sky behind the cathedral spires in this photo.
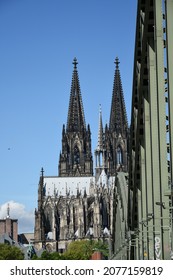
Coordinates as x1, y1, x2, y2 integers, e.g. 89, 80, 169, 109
0, 0, 137, 232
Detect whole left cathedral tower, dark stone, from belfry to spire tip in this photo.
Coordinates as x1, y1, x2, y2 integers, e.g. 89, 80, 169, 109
59, 58, 93, 177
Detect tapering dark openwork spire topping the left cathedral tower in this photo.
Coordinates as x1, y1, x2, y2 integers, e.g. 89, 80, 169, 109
67, 58, 86, 131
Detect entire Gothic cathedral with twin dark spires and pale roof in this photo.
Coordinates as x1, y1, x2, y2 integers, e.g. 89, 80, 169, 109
34, 58, 129, 252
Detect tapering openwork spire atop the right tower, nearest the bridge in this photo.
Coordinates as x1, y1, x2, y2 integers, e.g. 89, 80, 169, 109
109, 57, 128, 135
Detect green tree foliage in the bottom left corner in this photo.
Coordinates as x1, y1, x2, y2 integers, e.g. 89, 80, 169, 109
0, 244, 24, 260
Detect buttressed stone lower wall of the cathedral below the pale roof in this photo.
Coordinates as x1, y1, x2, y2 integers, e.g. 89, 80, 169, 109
35, 172, 114, 252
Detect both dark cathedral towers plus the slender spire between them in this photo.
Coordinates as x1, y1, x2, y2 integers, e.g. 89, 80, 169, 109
59, 58, 128, 177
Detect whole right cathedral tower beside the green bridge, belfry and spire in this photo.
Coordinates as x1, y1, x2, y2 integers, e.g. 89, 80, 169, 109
104, 58, 128, 176
